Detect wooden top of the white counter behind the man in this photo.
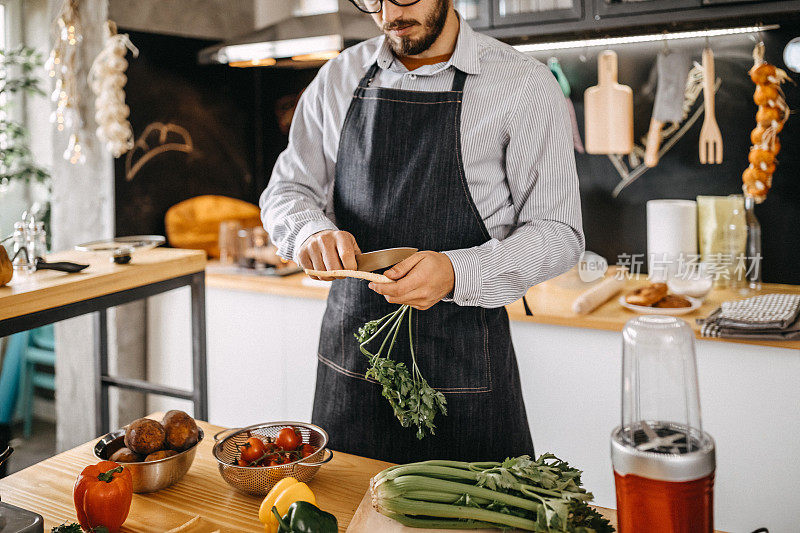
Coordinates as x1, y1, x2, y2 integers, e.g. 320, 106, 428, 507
206, 263, 800, 350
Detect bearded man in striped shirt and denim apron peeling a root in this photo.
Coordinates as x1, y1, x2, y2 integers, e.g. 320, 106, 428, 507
261, 0, 584, 462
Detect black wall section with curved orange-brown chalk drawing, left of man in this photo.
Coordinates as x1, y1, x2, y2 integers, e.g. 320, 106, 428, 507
115, 29, 264, 235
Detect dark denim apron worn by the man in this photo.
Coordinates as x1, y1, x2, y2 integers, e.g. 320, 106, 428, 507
312, 64, 533, 463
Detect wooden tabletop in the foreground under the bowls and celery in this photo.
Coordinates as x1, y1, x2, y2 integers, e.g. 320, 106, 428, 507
0, 413, 640, 533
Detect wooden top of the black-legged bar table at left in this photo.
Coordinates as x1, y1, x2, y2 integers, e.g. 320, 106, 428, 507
0, 248, 206, 320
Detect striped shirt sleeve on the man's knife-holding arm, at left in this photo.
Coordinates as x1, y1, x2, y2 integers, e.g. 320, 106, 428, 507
259, 61, 337, 261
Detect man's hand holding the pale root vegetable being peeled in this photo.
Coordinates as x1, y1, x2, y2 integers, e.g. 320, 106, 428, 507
369, 251, 455, 311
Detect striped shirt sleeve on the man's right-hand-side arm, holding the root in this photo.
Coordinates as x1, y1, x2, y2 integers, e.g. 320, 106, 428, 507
444, 65, 585, 307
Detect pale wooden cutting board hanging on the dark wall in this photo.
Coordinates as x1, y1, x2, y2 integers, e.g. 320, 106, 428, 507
583, 50, 633, 154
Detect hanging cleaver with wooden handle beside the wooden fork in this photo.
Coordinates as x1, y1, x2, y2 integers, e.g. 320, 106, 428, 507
644, 48, 690, 168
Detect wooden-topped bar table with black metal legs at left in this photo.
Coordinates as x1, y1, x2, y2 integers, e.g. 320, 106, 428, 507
0, 248, 208, 433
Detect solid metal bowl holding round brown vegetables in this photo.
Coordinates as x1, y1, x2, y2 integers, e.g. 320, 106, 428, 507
94, 428, 203, 494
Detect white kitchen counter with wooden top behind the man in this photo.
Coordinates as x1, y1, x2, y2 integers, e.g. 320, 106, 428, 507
148, 264, 800, 532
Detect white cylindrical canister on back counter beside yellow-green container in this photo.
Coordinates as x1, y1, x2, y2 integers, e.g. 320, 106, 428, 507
647, 200, 697, 281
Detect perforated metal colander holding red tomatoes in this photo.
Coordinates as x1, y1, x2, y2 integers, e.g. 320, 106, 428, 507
214, 422, 333, 496
